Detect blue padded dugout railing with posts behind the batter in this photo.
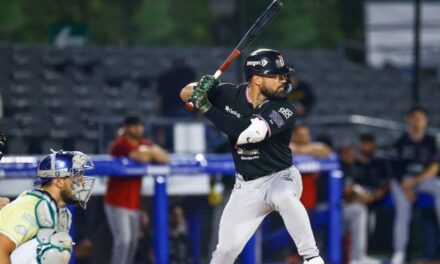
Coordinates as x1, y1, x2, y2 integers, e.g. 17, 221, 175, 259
0, 154, 342, 264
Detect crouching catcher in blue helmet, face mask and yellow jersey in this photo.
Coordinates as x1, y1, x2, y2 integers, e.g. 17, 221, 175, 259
0, 151, 94, 264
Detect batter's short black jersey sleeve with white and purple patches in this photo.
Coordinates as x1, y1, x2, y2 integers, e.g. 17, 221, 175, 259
254, 101, 296, 137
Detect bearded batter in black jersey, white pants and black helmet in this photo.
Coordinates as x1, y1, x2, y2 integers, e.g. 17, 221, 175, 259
180, 49, 324, 264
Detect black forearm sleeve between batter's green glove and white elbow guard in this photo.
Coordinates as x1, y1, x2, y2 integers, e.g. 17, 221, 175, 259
204, 107, 251, 138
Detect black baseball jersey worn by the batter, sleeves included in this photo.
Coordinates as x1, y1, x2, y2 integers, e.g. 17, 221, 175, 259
209, 83, 296, 181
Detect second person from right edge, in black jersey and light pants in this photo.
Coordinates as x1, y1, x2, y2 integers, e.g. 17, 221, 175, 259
341, 134, 391, 264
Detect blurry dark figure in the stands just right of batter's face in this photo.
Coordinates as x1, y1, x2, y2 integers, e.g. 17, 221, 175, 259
288, 74, 316, 117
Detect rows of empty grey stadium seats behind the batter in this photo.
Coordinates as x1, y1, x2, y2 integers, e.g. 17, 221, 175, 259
0, 43, 440, 154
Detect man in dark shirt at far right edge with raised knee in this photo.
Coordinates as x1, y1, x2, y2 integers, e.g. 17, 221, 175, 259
391, 106, 440, 264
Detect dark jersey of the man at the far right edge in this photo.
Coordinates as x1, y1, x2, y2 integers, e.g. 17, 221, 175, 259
392, 133, 438, 180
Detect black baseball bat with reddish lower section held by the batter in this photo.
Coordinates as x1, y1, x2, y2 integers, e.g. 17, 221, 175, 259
185, 0, 283, 111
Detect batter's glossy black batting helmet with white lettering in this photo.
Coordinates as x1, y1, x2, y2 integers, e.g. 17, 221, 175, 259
244, 49, 294, 81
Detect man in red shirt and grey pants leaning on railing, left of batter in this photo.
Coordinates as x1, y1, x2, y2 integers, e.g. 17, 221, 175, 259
104, 116, 168, 264
